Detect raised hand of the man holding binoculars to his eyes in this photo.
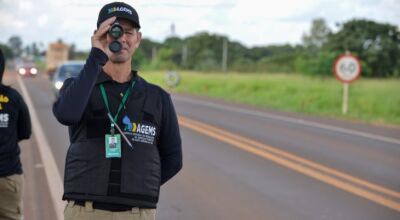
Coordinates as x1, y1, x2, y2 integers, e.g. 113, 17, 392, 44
92, 16, 116, 57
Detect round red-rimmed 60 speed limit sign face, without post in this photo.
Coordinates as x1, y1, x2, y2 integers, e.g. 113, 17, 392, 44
333, 54, 361, 83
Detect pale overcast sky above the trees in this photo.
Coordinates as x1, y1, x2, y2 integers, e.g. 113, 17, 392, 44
0, 0, 400, 50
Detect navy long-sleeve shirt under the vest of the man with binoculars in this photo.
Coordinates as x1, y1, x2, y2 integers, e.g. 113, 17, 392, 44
53, 48, 182, 184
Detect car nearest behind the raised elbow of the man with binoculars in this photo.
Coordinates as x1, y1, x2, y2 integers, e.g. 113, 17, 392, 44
52, 60, 85, 97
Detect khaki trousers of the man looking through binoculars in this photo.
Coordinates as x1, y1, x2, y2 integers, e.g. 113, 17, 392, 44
64, 201, 156, 220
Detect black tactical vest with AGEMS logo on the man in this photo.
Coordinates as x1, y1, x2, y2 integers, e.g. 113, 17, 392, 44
63, 76, 163, 208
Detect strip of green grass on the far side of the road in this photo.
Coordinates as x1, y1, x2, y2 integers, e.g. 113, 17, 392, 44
141, 72, 400, 125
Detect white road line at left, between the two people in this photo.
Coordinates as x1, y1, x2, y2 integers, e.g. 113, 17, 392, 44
17, 75, 66, 220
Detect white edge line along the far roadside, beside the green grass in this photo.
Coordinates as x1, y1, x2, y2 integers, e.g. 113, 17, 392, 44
174, 96, 400, 145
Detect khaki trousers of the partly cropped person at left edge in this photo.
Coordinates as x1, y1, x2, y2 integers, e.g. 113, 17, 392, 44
0, 174, 24, 220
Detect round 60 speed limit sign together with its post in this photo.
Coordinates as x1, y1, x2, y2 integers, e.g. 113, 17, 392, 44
333, 52, 361, 115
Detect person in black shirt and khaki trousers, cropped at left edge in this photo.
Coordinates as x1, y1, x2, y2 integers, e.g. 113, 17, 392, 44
0, 49, 31, 219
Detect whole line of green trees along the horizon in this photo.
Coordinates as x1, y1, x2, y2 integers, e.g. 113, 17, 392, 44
0, 18, 400, 77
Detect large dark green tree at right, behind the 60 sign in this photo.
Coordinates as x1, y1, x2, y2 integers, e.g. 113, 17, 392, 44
325, 19, 400, 77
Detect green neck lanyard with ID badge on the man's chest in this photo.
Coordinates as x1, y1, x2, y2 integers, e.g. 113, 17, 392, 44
100, 81, 135, 158
